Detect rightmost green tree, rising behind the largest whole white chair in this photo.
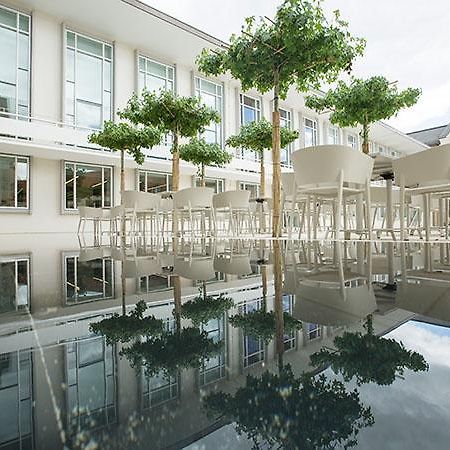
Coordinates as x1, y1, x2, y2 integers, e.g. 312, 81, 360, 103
306, 76, 421, 154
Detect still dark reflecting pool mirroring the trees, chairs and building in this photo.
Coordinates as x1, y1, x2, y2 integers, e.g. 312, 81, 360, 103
0, 233, 450, 450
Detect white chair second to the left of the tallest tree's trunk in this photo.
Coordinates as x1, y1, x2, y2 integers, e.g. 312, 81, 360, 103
173, 187, 215, 236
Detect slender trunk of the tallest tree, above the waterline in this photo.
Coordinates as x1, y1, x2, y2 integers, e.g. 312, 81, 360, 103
272, 72, 281, 237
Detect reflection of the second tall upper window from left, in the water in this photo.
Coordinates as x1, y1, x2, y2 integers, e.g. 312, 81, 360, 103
65, 337, 117, 436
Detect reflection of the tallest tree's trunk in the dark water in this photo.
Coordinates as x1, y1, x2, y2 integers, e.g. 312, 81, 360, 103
273, 241, 284, 371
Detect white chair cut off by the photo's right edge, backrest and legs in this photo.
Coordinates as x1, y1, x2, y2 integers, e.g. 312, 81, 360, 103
392, 144, 450, 240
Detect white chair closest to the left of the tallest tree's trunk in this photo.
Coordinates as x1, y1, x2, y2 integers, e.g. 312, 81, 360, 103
213, 190, 253, 236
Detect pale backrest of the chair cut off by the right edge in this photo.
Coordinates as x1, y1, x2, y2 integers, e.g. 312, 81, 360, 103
392, 144, 450, 186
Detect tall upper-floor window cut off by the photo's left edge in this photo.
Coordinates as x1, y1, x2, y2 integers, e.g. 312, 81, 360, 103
0, 6, 31, 118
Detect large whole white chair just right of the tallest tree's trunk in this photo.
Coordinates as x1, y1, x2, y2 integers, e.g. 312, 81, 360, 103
292, 145, 373, 239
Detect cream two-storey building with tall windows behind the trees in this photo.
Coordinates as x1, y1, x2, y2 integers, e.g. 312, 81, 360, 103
0, 0, 425, 233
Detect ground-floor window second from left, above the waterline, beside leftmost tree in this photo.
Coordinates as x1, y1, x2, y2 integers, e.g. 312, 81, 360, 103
64, 162, 112, 210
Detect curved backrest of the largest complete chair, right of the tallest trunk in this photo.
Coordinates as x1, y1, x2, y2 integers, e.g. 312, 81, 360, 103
292, 145, 373, 187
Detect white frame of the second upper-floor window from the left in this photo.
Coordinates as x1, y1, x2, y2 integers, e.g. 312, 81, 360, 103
65, 26, 115, 131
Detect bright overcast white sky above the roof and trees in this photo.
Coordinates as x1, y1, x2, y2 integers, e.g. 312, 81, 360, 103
144, 0, 450, 132
